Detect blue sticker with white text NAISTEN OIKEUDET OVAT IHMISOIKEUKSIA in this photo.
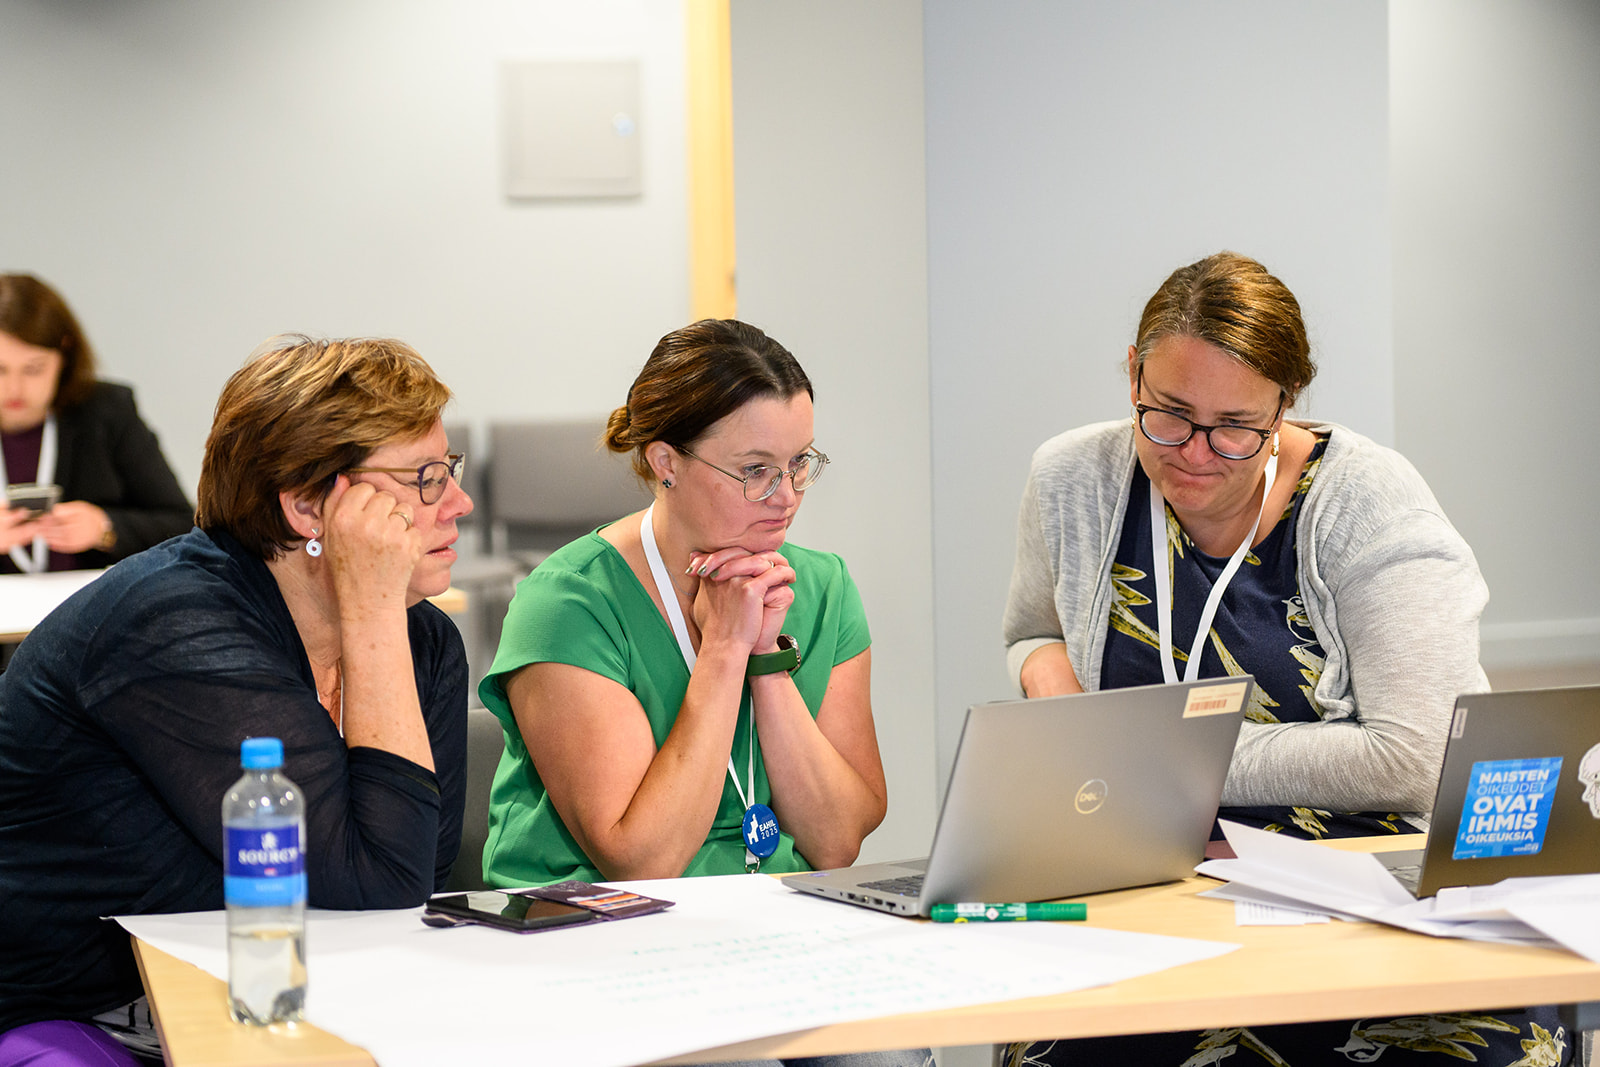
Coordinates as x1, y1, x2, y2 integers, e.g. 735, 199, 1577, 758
1453, 757, 1562, 859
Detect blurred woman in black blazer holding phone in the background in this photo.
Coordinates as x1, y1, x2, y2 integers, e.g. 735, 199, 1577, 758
0, 274, 194, 574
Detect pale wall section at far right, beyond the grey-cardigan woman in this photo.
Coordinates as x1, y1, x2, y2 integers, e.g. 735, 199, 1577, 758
1390, 0, 1600, 669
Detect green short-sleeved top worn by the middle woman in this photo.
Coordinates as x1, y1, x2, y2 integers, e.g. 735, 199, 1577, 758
478, 533, 872, 886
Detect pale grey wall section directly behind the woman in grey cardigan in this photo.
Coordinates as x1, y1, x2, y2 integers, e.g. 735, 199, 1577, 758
925, 0, 1394, 781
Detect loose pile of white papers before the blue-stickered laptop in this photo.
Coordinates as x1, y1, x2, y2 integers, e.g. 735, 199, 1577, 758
1195, 821, 1600, 963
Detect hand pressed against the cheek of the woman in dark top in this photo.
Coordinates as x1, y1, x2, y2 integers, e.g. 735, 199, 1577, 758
320, 474, 422, 617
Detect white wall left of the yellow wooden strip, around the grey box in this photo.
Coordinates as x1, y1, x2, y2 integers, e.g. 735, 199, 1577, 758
0, 0, 688, 491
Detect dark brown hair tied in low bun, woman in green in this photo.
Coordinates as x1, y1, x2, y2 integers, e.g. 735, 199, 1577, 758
605, 318, 814, 482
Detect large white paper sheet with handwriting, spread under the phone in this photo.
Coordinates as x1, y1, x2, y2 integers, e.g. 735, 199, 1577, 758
118, 875, 1237, 1067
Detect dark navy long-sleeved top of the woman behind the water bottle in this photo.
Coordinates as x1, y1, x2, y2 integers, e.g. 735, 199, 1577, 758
0, 530, 467, 1032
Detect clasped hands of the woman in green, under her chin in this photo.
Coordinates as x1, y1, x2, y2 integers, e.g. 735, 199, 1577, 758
690, 549, 795, 653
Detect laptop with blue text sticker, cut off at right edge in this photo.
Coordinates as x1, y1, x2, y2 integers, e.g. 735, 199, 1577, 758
1381, 686, 1600, 897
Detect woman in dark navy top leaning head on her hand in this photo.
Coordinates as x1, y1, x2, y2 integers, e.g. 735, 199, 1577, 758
0, 339, 472, 1064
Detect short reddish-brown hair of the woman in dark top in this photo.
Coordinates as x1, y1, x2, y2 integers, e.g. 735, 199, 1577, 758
195, 334, 450, 560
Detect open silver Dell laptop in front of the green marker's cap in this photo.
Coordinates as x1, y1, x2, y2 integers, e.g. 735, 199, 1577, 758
784, 675, 1254, 915
